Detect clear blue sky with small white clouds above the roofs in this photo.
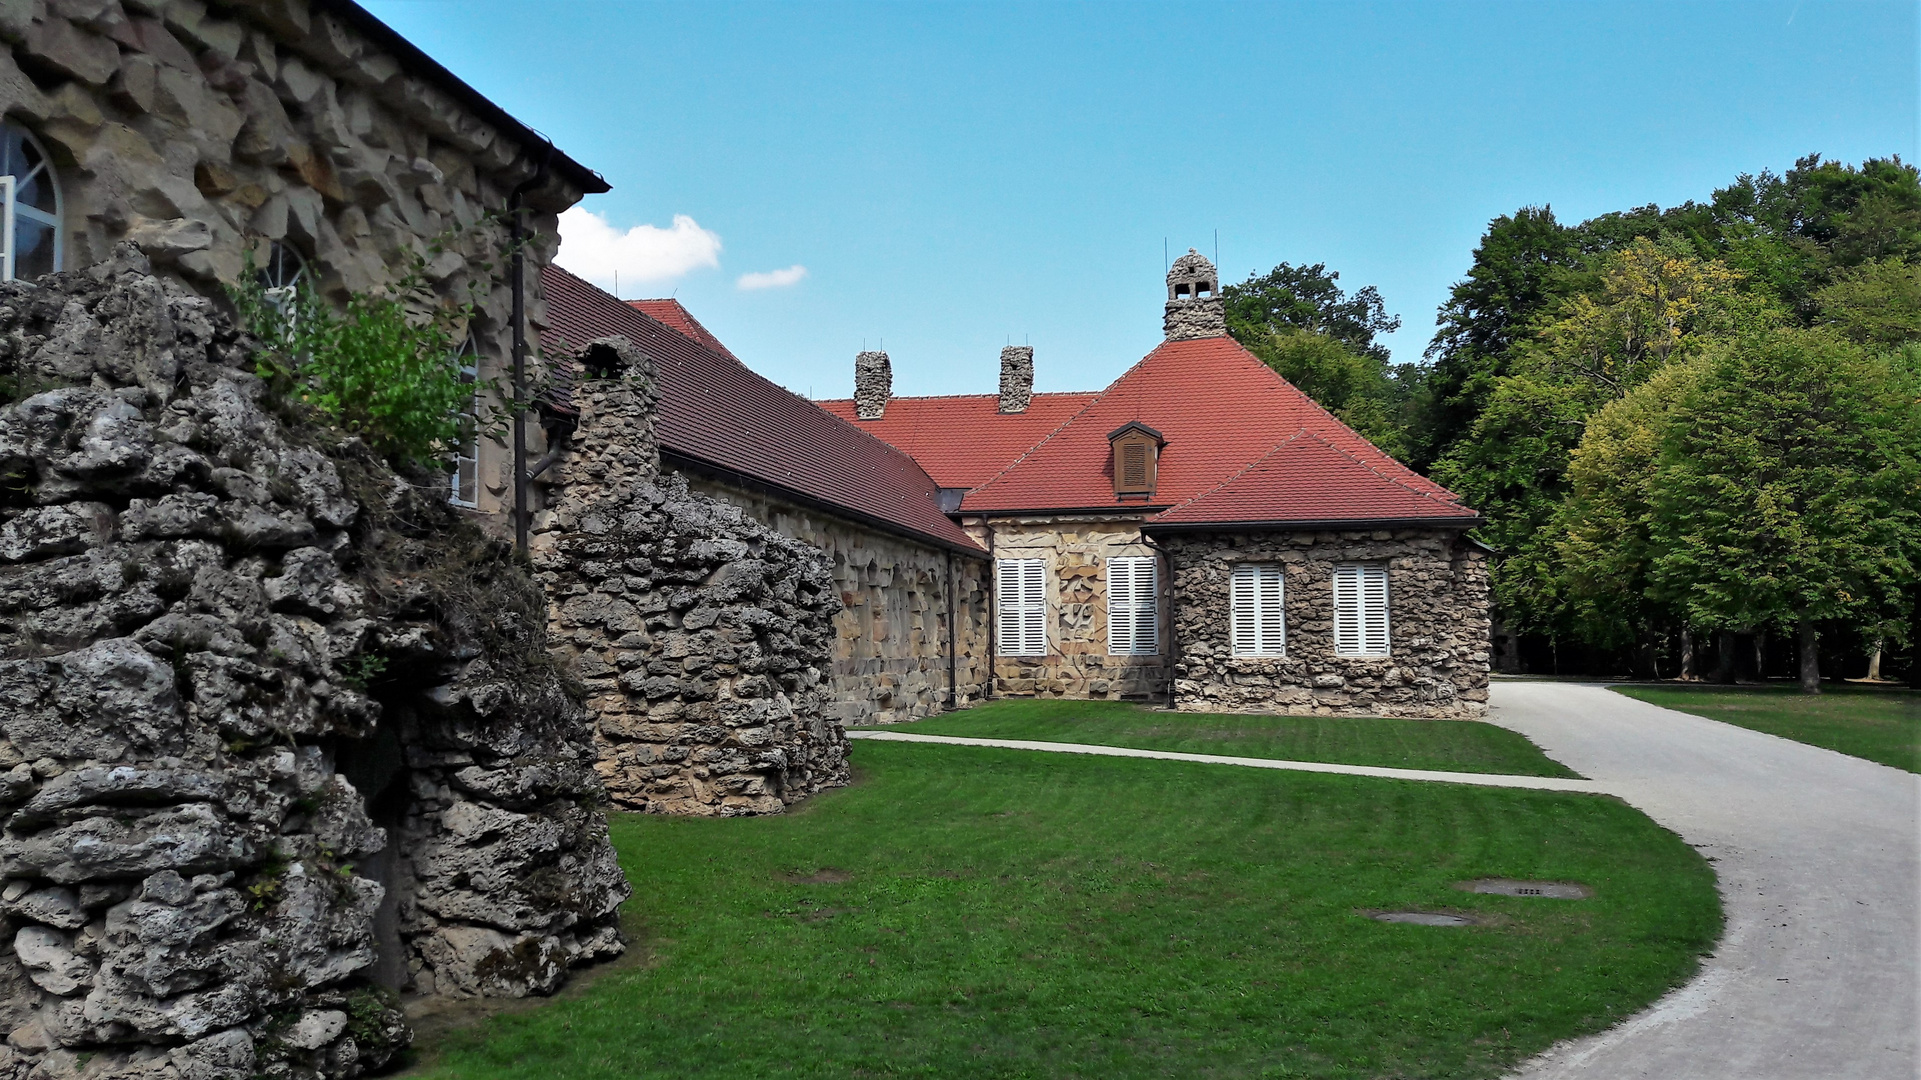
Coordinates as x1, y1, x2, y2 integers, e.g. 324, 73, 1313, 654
367, 0, 1921, 398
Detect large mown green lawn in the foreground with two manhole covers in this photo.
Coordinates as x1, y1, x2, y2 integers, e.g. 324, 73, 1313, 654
413, 742, 1721, 1080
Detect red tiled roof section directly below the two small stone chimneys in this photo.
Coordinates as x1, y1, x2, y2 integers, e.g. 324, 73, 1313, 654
815, 394, 1099, 488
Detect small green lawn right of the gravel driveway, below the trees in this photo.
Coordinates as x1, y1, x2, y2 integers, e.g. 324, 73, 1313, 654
1616, 686, 1921, 773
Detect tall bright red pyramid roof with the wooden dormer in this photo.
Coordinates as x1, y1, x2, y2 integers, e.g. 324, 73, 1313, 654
960, 336, 1471, 519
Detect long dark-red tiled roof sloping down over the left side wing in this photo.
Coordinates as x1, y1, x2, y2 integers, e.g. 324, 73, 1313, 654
540, 265, 980, 552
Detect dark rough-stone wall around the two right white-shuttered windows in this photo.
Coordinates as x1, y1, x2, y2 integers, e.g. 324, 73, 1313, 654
1160, 528, 1489, 717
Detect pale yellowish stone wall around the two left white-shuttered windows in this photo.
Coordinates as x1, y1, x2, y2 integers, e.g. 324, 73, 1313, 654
968, 517, 1168, 700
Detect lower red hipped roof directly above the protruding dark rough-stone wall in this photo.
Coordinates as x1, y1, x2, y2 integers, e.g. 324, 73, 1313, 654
1149, 429, 1479, 528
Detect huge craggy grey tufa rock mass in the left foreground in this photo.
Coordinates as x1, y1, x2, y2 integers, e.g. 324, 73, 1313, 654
0, 246, 626, 1080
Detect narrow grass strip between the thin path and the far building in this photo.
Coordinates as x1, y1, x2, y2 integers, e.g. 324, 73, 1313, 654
886, 700, 1577, 776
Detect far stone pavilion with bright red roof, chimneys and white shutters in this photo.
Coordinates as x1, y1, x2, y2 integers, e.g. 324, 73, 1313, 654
820, 250, 1489, 717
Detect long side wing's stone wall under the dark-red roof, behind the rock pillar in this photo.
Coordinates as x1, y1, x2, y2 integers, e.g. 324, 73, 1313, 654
688, 477, 993, 724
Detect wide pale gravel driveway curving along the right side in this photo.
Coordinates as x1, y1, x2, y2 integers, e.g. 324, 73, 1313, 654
1487, 682, 1921, 1080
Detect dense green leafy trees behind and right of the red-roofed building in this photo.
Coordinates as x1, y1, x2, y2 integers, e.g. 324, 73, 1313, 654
1224, 156, 1921, 688
